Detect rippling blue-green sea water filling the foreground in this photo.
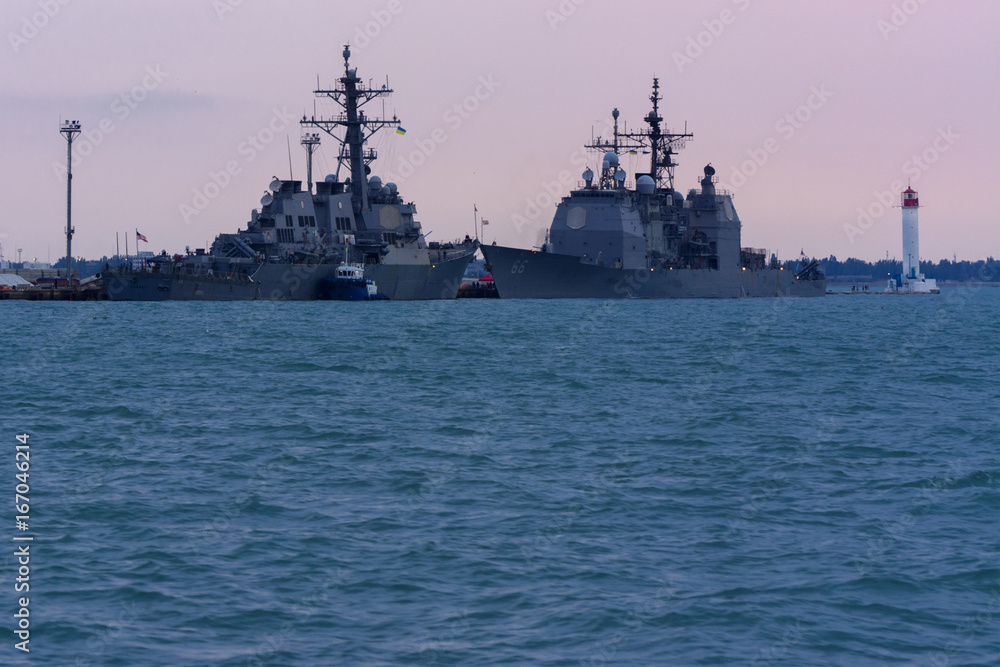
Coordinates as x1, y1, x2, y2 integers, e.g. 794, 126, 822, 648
0, 288, 1000, 666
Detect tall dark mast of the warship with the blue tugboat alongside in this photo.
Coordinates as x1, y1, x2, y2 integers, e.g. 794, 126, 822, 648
301, 45, 399, 215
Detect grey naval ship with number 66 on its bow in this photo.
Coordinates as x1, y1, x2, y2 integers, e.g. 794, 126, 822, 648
482, 79, 826, 299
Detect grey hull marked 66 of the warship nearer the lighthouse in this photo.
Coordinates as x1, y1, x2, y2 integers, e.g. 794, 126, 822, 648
481, 245, 826, 299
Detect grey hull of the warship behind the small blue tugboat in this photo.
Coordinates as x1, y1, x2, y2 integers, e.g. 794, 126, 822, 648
101, 252, 473, 301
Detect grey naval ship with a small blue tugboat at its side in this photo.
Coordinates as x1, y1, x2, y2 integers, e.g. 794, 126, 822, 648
101, 47, 479, 301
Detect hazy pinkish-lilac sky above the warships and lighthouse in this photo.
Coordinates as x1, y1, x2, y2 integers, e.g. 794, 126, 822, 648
0, 0, 1000, 262
